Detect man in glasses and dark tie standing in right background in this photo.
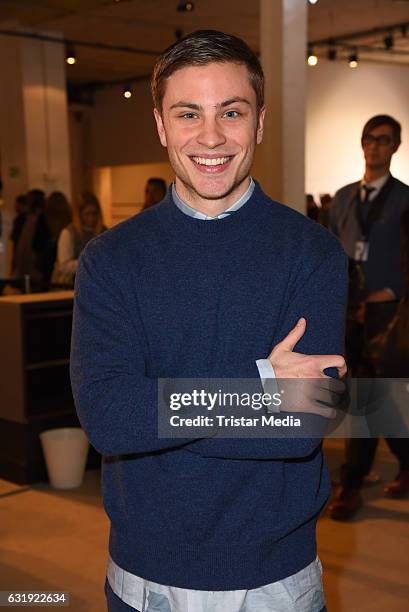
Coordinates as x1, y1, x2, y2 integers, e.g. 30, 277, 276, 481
328, 115, 409, 520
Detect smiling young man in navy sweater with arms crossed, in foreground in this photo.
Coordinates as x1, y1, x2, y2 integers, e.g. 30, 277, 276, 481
71, 31, 347, 612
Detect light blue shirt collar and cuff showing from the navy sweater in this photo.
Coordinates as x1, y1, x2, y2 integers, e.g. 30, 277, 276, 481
172, 177, 280, 396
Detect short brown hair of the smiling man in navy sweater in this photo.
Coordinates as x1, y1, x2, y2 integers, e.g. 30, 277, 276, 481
151, 30, 264, 112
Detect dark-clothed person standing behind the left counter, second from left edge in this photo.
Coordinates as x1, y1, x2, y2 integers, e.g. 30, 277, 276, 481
13, 189, 50, 291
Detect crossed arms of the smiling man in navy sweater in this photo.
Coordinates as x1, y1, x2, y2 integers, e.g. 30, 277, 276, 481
71, 239, 346, 459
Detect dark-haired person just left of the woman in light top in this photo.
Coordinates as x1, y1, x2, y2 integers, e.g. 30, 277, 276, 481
44, 191, 72, 283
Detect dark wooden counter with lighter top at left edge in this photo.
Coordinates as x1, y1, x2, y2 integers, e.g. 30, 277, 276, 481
0, 291, 99, 483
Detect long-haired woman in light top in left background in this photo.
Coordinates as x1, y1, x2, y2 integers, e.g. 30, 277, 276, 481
52, 192, 107, 287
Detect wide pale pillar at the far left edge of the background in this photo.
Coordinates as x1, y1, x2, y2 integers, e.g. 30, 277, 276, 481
0, 24, 71, 276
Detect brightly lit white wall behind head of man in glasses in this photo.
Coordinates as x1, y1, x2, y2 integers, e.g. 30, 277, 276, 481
306, 60, 409, 195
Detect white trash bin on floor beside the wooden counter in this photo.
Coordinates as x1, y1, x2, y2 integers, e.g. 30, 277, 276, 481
40, 427, 89, 489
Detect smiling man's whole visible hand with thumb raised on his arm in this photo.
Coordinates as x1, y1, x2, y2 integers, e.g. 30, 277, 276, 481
269, 318, 347, 419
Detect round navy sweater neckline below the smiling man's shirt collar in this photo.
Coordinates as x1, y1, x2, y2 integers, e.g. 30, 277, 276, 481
156, 181, 268, 244
